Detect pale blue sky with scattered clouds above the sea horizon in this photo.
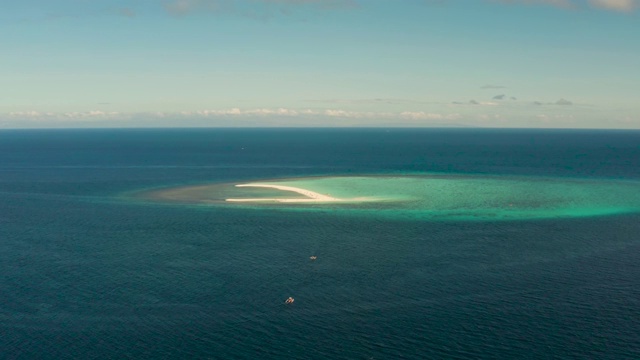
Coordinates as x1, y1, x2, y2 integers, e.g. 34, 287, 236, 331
0, 0, 640, 129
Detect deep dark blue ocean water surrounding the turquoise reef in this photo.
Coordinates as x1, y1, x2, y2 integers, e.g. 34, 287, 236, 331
0, 129, 640, 359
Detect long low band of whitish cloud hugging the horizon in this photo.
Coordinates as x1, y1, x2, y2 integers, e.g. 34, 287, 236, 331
0, 108, 461, 128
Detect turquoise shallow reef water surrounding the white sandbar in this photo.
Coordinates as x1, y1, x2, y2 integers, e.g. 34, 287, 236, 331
150, 174, 640, 221
